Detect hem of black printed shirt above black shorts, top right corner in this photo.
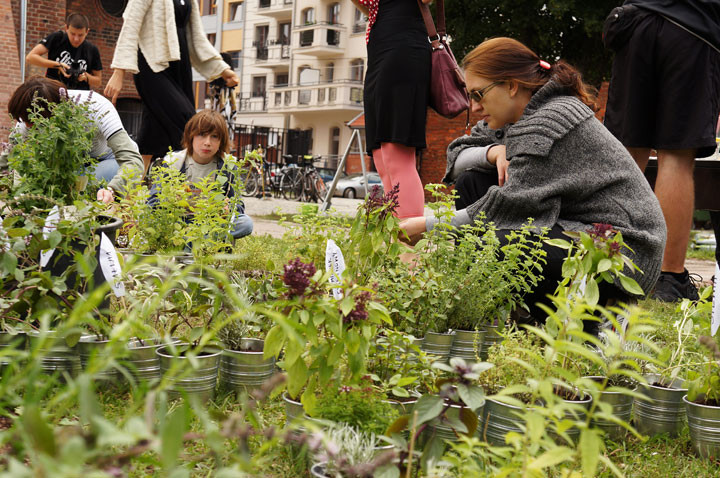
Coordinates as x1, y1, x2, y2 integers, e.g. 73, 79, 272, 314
625, 0, 720, 48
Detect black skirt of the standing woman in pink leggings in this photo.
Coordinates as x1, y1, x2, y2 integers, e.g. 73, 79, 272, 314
363, 0, 431, 154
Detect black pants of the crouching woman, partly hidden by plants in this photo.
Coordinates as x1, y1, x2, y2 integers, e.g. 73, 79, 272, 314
455, 171, 631, 329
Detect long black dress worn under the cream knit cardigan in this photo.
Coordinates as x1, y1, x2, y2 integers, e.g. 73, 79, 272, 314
133, 0, 195, 157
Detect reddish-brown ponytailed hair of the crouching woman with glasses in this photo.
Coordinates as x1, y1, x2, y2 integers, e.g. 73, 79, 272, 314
462, 37, 597, 111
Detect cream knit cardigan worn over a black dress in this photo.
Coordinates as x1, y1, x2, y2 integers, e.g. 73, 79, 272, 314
110, 0, 230, 80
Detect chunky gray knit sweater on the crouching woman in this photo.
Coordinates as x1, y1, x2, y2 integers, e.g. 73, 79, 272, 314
443, 80, 666, 293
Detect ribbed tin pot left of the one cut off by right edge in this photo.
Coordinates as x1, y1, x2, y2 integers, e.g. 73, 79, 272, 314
634, 375, 687, 437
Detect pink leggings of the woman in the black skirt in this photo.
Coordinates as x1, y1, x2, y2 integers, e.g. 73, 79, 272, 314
373, 143, 425, 219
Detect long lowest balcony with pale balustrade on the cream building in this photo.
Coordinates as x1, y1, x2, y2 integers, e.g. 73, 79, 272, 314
268, 80, 363, 113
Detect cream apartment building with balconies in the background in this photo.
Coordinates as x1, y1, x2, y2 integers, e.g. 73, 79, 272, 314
196, 0, 367, 162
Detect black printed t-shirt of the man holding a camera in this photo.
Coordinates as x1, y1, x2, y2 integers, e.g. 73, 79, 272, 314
40, 30, 102, 90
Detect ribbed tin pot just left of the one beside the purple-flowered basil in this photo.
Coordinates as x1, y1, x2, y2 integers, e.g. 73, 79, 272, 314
155, 344, 222, 402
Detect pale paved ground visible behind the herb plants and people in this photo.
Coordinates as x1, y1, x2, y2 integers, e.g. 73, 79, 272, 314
245, 198, 715, 284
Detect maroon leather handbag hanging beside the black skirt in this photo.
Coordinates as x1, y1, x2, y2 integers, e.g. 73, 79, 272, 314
418, 0, 470, 118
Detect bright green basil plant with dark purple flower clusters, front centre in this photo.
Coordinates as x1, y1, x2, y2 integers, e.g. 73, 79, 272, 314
258, 259, 390, 422
